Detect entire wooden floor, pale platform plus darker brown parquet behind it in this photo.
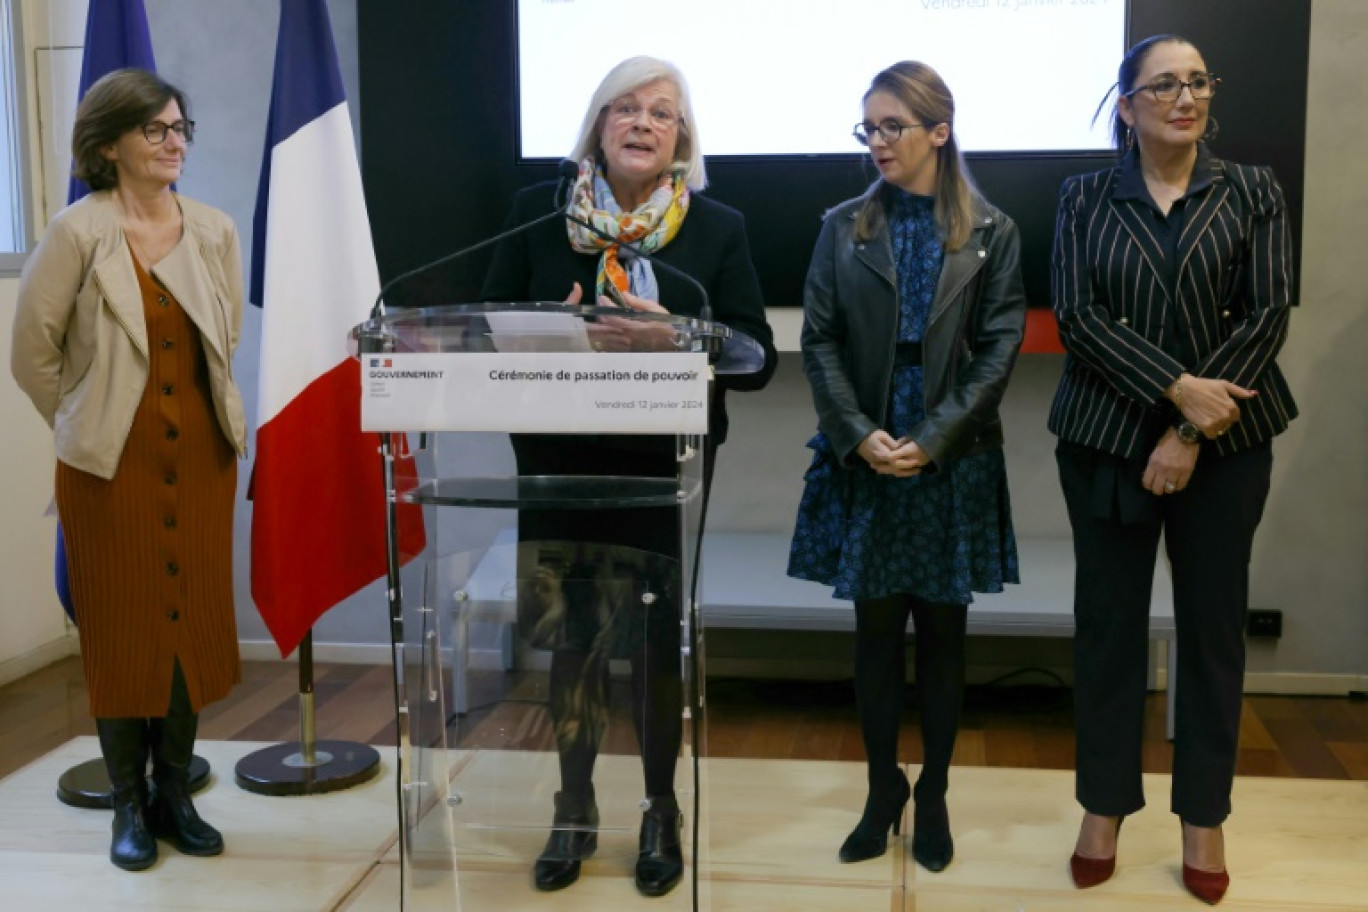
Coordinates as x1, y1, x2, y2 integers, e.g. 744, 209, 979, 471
0, 659, 1368, 912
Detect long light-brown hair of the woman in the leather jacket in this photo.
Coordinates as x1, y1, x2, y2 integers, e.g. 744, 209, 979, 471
855, 60, 978, 250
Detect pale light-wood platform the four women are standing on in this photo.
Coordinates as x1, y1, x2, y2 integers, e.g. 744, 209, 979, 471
0, 737, 1368, 912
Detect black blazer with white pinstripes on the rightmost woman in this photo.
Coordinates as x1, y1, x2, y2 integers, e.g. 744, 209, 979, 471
1049, 159, 1297, 457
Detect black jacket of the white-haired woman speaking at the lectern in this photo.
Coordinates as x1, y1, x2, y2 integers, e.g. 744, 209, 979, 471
482, 182, 777, 446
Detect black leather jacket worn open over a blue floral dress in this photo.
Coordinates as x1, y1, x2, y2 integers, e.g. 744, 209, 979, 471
803, 182, 1026, 468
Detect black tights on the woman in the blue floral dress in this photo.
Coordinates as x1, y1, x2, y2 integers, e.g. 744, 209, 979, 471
855, 595, 967, 796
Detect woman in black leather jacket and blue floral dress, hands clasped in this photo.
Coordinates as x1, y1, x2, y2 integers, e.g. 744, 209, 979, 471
789, 62, 1026, 871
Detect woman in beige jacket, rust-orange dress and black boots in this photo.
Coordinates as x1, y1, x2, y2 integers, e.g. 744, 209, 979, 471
11, 70, 246, 871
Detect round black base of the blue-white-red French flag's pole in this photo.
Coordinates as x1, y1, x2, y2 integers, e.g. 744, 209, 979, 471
235, 741, 380, 794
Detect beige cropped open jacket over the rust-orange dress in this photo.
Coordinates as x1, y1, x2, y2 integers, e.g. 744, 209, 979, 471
10, 190, 246, 479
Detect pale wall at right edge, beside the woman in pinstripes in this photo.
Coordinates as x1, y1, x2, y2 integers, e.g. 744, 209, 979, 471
1250, 0, 1368, 689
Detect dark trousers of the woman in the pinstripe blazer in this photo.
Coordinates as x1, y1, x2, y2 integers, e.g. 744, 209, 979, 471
1056, 443, 1272, 827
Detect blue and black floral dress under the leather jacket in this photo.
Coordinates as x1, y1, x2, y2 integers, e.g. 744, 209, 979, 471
788, 190, 1019, 604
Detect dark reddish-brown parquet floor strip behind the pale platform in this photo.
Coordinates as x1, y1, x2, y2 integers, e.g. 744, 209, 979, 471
0, 658, 1368, 781
